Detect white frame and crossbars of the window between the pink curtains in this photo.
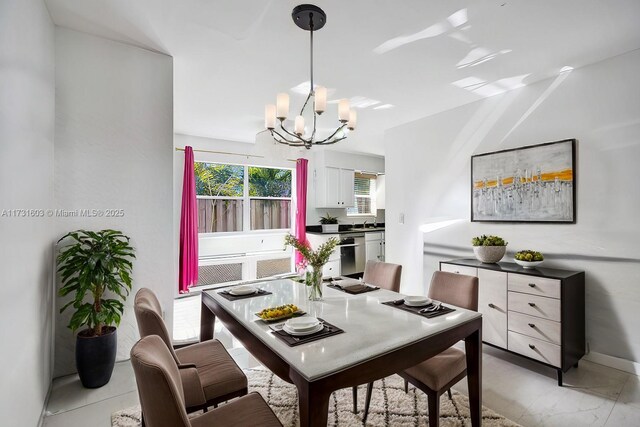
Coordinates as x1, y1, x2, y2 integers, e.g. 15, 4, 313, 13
195, 160, 296, 237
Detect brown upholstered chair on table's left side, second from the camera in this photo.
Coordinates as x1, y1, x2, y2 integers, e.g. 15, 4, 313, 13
134, 288, 247, 415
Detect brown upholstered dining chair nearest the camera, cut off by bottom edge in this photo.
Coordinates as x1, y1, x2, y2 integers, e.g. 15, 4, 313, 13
131, 335, 282, 427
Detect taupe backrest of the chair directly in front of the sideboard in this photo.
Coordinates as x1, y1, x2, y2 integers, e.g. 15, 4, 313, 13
429, 271, 478, 311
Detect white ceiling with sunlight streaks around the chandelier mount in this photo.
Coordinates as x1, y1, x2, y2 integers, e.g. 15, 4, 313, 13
46, 0, 640, 154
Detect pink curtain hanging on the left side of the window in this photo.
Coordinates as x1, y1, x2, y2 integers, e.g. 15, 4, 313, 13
178, 147, 198, 294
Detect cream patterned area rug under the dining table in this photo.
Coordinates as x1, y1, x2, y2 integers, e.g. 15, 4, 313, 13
111, 370, 519, 427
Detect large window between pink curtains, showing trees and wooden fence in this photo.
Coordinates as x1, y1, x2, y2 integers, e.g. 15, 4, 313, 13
194, 162, 292, 233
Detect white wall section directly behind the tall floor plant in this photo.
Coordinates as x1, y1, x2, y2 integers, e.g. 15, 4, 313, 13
54, 27, 177, 376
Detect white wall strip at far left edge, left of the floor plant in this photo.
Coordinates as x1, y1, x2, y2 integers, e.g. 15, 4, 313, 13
0, 0, 55, 426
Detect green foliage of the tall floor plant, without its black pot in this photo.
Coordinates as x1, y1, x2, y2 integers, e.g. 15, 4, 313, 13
58, 230, 135, 336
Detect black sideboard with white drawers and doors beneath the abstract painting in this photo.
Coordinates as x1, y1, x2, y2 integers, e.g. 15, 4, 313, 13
440, 259, 585, 386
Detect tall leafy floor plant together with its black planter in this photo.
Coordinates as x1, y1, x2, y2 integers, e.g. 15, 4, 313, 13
58, 230, 135, 388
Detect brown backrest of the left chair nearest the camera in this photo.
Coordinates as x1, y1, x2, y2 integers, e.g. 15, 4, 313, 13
131, 335, 191, 427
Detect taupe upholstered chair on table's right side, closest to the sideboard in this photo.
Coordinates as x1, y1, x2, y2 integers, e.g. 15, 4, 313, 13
364, 271, 478, 427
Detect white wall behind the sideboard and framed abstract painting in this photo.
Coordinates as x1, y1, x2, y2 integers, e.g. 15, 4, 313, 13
385, 51, 640, 362
